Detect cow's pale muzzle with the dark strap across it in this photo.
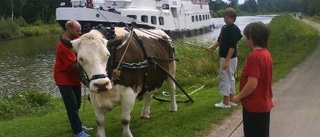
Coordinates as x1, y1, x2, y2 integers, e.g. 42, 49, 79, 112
90, 74, 112, 92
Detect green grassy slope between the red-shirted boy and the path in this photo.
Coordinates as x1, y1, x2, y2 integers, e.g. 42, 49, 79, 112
268, 15, 319, 80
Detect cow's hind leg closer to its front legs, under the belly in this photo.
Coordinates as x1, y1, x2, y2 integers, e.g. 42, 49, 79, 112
140, 91, 153, 119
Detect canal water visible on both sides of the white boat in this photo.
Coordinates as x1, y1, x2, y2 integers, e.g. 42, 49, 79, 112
0, 16, 274, 95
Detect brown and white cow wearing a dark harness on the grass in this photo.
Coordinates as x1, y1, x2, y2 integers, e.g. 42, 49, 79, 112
62, 27, 177, 137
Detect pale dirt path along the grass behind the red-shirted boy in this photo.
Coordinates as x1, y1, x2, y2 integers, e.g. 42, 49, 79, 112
206, 20, 320, 137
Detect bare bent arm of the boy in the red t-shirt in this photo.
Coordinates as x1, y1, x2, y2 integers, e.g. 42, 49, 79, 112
232, 76, 258, 102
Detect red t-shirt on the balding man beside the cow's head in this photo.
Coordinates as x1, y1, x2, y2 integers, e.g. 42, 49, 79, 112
53, 41, 81, 86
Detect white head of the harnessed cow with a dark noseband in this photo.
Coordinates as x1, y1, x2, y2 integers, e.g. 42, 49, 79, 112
64, 30, 112, 92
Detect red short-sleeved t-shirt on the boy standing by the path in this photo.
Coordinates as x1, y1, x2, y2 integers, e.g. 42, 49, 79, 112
240, 49, 273, 112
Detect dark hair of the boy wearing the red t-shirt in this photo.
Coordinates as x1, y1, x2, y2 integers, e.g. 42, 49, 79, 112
243, 21, 270, 48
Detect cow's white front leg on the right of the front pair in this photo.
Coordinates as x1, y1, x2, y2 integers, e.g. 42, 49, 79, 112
121, 88, 137, 137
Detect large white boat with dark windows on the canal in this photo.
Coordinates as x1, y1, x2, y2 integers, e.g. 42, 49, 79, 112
56, 0, 214, 37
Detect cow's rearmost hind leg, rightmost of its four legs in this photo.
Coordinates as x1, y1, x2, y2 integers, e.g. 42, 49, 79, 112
167, 61, 178, 112
